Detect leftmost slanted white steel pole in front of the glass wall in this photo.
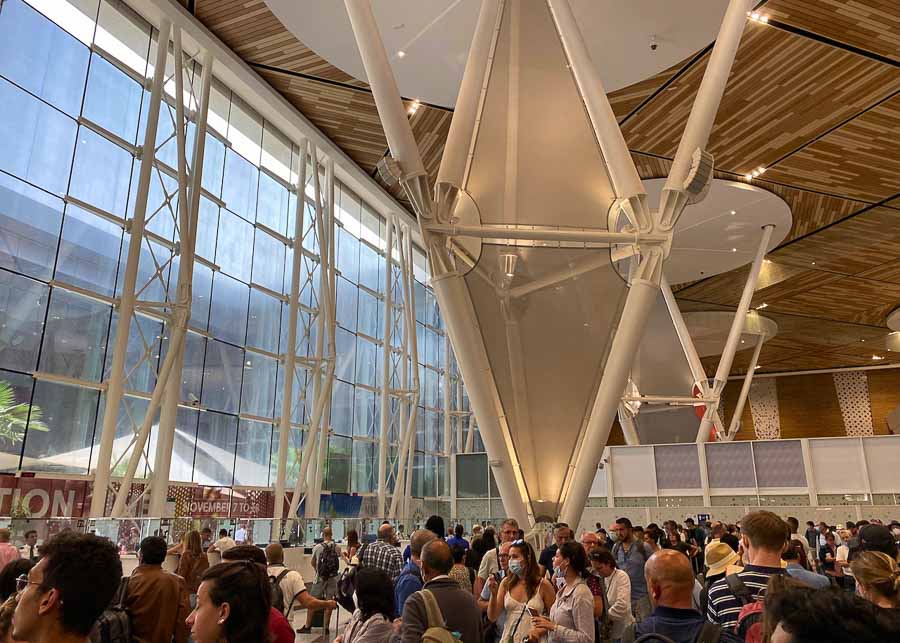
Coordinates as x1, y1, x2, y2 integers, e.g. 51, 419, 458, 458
91, 19, 172, 518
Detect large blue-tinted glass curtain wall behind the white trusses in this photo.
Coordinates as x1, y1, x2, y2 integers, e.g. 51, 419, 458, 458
0, 0, 467, 506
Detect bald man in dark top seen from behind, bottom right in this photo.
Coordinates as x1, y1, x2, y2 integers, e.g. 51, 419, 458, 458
626, 549, 737, 643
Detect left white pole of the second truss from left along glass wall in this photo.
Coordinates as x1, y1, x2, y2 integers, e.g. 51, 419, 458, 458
272, 138, 309, 536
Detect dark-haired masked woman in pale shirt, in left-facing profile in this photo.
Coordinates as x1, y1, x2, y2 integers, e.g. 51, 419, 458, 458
528, 542, 594, 643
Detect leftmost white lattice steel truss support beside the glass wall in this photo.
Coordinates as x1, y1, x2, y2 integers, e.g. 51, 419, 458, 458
90, 18, 212, 518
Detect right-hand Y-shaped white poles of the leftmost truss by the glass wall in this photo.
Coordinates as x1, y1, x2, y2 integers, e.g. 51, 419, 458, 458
149, 35, 212, 517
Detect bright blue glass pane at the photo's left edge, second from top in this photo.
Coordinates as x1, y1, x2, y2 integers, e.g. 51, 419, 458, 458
0, 78, 77, 195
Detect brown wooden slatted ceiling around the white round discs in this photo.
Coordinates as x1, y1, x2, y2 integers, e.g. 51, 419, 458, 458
196, 0, 900, 373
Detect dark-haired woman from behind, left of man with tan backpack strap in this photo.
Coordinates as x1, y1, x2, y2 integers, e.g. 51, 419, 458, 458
334, 567, 394, 643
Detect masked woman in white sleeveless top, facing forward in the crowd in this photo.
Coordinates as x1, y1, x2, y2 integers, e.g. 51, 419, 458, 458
488, 541, 556, 643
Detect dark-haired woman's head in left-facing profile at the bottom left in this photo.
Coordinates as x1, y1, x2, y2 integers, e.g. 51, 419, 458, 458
186, 560, 271, 643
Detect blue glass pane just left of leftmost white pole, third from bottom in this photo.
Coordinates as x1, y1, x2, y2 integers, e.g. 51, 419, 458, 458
56, 205, 123, 295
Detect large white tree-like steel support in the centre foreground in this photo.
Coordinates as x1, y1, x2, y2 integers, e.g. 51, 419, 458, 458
345, 0, 750, 525
